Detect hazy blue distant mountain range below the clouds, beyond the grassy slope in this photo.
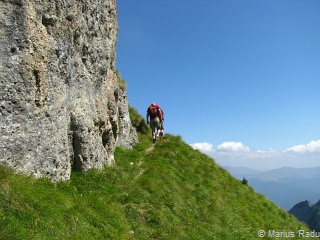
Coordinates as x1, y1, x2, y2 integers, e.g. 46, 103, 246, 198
225, 167, 320, 210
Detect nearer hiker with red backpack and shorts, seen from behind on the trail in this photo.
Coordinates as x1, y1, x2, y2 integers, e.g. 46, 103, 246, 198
146, 102, 162, 142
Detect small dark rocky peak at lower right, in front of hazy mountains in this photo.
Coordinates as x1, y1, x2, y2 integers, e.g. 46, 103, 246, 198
289, 200, 320, 232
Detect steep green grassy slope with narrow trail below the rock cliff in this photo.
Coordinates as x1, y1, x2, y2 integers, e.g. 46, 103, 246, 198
0, 110, 316, 240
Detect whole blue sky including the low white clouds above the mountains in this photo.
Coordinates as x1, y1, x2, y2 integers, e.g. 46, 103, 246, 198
117, 0, 320, 169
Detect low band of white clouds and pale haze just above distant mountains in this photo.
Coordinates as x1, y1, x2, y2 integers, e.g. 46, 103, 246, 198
191, 140, 320, 170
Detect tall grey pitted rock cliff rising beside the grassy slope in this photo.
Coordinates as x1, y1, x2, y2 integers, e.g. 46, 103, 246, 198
0, 0, 136, 181
